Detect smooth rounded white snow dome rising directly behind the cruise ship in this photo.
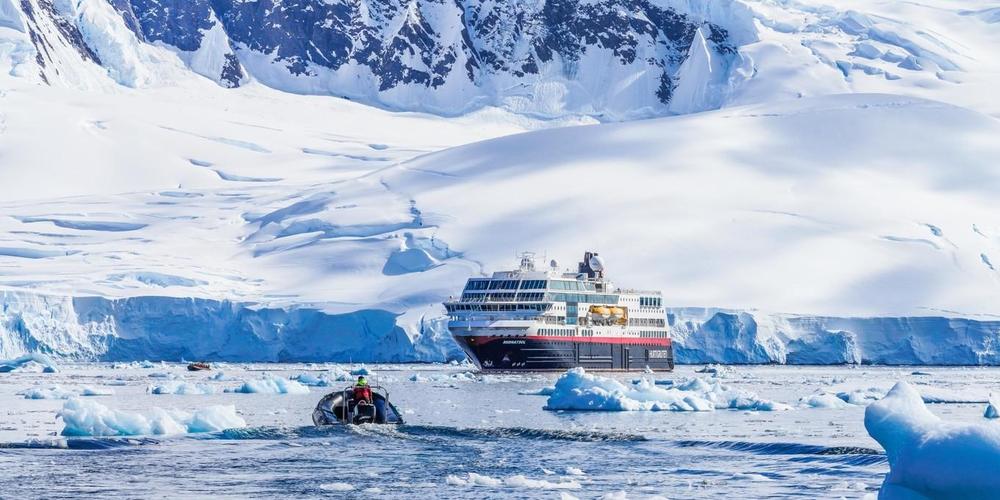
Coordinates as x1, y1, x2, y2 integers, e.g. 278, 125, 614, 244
380, 95, 1000, 319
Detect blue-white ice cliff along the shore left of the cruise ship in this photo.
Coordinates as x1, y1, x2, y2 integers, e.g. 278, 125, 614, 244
0, 292, 463, 362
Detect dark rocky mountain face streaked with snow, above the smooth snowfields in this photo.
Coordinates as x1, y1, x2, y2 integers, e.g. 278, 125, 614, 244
0, 0, 750, 118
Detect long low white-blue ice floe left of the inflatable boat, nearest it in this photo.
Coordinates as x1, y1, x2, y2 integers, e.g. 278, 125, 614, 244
58, 398, 247, 436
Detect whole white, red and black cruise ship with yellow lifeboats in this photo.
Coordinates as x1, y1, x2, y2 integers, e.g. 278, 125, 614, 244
444, 252, 674, 371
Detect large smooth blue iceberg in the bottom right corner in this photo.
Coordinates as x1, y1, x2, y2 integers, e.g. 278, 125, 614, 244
865, 382, 1000, 499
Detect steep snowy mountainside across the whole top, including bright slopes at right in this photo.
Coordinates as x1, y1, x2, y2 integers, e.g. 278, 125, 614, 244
0, 0, 1000, 120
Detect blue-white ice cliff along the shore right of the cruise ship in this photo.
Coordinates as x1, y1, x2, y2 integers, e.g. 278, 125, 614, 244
668, 308, 1000, 365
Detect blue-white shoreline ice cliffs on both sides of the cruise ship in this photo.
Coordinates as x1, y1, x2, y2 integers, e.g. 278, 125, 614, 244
0, 292, 1000, 365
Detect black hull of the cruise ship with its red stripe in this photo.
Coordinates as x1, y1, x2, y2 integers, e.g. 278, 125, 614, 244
455, 335, 674, 371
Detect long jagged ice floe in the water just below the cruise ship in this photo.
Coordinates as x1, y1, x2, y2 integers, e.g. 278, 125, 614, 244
545, 368, 791, 411
